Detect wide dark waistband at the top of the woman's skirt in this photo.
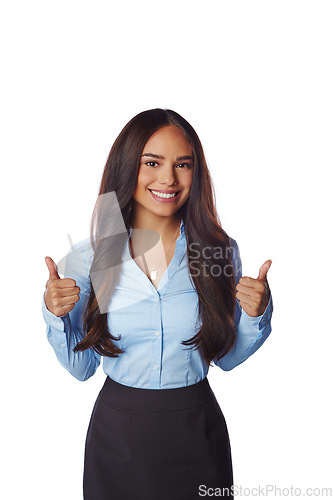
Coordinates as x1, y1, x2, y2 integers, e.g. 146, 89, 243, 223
99, 376, 215, 413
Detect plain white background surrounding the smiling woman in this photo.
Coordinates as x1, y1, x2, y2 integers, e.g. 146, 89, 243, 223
0, 0, 333, 500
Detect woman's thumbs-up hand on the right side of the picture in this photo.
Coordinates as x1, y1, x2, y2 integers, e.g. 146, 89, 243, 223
236, 260, 272, 317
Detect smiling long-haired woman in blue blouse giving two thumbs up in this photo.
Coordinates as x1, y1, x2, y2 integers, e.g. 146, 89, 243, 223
43, 109, 273, 500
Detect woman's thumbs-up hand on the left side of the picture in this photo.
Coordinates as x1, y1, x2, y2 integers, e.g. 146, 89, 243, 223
44, 257, 80, 317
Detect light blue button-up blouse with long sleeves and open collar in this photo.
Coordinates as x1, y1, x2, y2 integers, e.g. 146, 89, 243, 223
42, 221, 273, 389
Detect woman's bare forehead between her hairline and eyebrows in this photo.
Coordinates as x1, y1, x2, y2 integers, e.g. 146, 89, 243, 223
143, 125, 192, 154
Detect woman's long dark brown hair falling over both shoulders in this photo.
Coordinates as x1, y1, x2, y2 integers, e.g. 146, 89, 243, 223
74, 108, 236, 364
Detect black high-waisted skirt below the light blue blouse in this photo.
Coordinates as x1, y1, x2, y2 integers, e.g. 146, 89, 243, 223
83, 376, 233, 500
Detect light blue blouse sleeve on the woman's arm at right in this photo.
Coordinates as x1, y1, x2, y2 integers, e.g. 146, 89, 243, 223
214, 238, 273, 371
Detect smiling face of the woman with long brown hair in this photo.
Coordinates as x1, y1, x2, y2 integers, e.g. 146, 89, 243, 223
133, 125, 193, 216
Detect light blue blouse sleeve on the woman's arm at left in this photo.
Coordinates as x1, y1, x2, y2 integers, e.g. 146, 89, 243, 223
42, 240, 101, 381
